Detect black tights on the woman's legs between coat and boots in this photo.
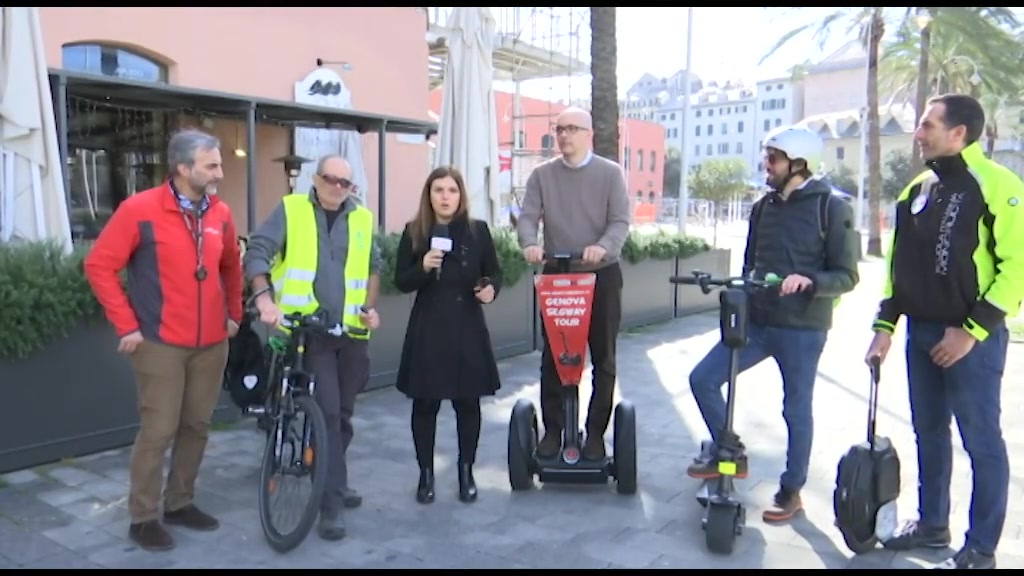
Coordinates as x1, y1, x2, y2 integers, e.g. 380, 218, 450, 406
413, 398, 480, 469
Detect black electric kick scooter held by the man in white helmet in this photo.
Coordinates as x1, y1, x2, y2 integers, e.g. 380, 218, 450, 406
669, 271, 781, 554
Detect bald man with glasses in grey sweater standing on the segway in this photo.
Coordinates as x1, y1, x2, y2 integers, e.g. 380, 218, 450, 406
517, 108, 630, 460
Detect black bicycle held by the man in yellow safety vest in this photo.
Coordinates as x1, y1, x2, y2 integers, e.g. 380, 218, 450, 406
240, 310, 333, 552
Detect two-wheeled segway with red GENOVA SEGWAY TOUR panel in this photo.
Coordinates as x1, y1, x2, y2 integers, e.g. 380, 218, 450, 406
508, 252, 637, 494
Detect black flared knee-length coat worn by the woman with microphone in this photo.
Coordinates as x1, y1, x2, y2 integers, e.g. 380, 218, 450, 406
394, 216, 502, 400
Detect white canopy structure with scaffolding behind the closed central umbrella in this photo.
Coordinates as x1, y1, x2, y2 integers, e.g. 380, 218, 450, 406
426, 7, 590, 89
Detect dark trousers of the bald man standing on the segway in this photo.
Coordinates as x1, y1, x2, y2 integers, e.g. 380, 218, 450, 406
541, 263, 623, 436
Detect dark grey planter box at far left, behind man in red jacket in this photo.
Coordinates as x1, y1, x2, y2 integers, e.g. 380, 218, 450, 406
0, 321, 239, 474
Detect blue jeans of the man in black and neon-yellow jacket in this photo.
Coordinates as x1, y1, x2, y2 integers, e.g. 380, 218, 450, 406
906, 320, 1010, 554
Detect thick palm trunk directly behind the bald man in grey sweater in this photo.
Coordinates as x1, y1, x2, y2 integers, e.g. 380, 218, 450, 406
590, 6, 618, 162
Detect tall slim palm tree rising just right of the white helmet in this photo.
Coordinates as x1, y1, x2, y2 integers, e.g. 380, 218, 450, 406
761, 7, 886, 256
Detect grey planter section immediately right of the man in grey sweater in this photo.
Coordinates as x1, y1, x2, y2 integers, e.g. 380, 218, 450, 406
621, 258, 676, 330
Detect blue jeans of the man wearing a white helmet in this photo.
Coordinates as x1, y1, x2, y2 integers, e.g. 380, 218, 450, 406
690, 324, 828, 491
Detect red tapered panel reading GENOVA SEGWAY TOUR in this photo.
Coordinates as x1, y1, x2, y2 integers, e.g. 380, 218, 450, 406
534, 273, 597, 386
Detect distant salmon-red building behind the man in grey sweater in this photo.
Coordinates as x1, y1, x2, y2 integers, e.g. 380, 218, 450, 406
429, 87, 665, 204
